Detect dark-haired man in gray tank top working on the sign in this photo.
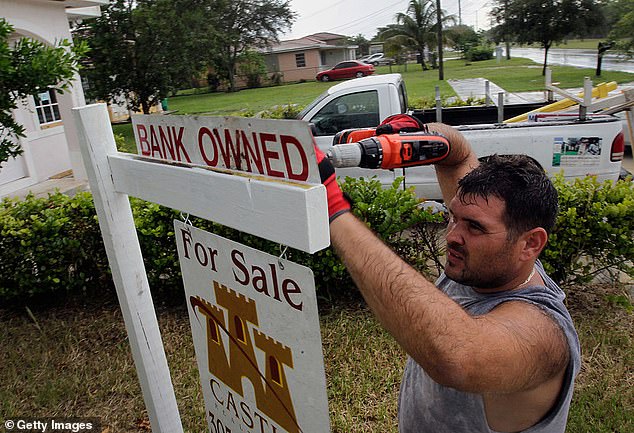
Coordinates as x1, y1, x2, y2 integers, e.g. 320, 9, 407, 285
318, 124, 580, 433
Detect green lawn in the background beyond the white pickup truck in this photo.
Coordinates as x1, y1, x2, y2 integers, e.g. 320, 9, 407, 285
113, 58, 634, 153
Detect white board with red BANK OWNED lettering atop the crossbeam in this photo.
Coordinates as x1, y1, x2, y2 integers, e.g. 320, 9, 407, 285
132, 115, 320, 184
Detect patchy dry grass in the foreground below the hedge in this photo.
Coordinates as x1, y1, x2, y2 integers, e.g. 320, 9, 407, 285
0, 286, 634, 433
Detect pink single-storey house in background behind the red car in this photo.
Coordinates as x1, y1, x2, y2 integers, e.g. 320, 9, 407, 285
262, 33, 358, 82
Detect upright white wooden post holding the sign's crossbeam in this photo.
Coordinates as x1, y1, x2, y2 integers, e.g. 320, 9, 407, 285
73, 104, 183, 433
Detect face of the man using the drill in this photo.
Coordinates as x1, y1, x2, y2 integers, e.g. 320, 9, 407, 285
445, 196, 520, 291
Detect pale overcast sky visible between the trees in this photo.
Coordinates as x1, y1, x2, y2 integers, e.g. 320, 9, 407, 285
280, 0, 491, 40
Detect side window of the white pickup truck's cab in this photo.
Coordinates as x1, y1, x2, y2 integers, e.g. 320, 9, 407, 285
310, 90, 379, 136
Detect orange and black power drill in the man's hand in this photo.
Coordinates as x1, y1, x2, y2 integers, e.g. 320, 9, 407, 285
326, 129, 451, 170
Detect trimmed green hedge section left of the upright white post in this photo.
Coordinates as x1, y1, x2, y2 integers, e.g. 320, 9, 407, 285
0, 193, 109, 302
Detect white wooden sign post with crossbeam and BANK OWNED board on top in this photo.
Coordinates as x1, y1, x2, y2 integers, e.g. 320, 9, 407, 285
73, 104, 330, 433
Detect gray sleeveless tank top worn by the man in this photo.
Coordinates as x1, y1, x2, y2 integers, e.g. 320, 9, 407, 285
398, 262, 581, 433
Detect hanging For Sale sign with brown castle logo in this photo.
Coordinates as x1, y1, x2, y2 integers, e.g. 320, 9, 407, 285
174, 221, 330, 433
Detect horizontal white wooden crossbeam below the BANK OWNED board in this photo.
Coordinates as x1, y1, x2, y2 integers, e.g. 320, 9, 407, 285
108, 154, 330, 253
